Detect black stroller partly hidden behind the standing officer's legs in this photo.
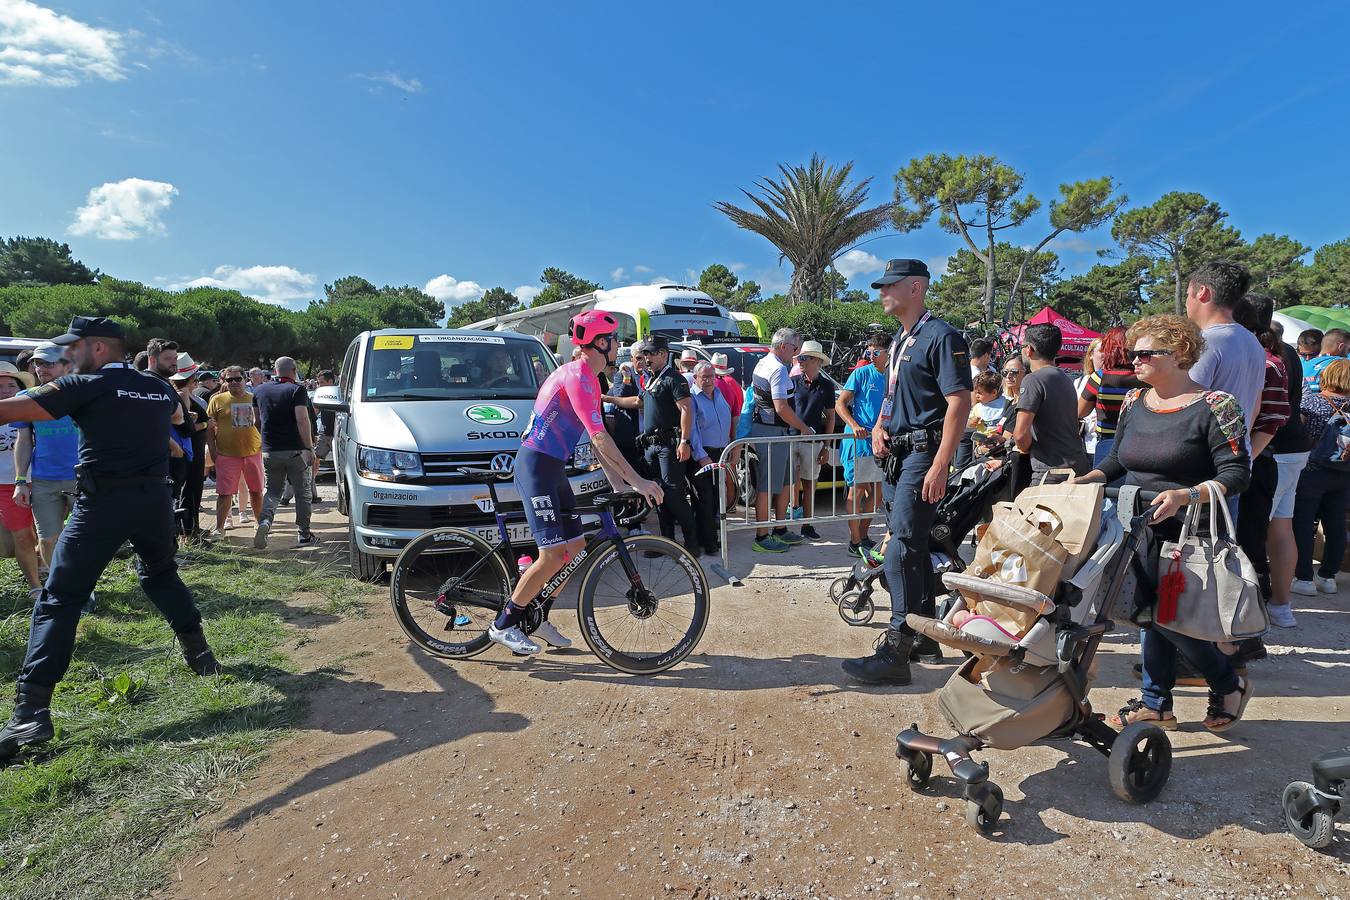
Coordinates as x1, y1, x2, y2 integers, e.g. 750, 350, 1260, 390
829, 460, 1013, 631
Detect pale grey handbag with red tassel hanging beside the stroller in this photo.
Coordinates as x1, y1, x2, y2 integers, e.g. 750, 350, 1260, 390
1154, 482, 1270, 642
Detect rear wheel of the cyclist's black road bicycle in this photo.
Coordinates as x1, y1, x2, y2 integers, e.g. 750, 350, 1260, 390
389, 528, 512, 660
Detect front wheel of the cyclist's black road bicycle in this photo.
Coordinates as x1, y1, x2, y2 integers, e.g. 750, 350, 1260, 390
576, 534, 709, 675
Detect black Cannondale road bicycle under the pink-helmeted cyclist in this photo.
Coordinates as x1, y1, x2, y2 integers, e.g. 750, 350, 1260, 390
389, 468, 709, 675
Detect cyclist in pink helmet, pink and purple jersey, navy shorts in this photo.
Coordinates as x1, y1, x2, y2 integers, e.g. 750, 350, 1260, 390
487, 309, 663, 654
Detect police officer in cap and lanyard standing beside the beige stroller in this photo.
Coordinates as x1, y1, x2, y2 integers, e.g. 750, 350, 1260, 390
844, 259, 971, 684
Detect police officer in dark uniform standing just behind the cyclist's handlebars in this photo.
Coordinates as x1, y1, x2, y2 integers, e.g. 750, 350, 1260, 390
637, 335, 702, 556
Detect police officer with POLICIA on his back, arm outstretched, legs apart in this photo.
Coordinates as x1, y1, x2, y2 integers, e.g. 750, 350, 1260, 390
0, 316, 220, 761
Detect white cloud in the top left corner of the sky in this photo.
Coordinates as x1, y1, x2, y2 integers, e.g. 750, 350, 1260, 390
0, 0, 127, 88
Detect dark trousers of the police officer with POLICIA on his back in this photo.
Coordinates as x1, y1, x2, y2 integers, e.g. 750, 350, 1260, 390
19, 482, 201, 685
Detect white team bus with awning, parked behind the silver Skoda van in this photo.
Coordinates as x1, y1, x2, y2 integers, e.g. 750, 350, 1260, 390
466, 283, 765, 359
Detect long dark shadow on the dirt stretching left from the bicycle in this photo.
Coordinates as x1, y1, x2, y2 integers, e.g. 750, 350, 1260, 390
210, 648, 529, 828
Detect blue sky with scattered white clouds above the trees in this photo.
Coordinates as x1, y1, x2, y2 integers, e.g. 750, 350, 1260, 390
0, 0, 1350, 306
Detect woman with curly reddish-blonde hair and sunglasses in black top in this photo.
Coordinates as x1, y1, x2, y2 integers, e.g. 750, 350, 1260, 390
1077, 316, 1251, 731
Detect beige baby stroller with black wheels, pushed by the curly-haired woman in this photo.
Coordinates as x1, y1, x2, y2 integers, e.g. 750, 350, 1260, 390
895, 487, 1172, 834
